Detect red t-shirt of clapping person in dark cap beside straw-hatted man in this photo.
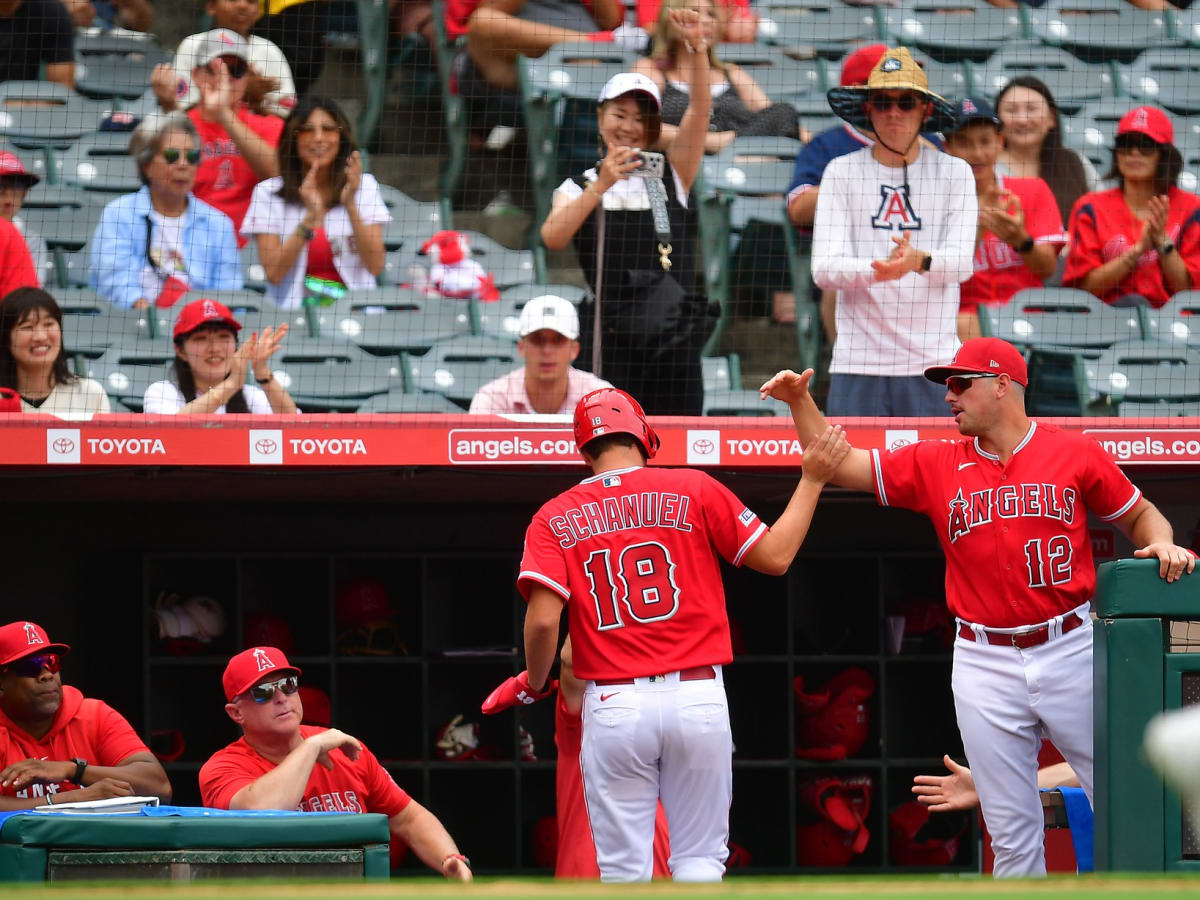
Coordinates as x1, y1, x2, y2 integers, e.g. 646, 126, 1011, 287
959, 175, 1067, 312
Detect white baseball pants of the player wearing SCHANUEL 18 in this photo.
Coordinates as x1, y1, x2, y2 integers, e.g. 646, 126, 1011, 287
580, 666, 733, 882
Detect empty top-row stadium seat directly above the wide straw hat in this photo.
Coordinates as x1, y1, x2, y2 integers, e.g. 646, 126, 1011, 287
877, 0, 1031, 62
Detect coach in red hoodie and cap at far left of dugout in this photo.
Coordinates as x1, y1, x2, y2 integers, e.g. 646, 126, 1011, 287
0, 622, 170, 812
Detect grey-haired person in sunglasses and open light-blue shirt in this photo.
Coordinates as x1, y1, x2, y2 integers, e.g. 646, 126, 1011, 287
89, 113, 242, 310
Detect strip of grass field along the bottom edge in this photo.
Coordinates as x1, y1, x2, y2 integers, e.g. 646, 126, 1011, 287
0, 875, 1200, 900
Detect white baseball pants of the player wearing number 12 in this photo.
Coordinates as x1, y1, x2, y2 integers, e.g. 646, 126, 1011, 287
952, 604, 1092, 877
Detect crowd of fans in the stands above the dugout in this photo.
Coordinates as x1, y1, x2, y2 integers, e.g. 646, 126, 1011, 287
0, 0, 1200, 415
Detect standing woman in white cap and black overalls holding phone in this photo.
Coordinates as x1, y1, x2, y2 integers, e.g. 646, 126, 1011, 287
541, 10, 713, 415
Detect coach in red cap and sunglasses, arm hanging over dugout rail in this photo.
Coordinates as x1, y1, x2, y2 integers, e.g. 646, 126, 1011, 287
200, 647, 472, 881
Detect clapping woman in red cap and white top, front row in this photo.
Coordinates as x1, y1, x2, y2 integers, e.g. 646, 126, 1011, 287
142, 298, 298, 415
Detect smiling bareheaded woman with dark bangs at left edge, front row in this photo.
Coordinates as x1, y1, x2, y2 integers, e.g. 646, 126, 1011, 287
0, 288, 109, 419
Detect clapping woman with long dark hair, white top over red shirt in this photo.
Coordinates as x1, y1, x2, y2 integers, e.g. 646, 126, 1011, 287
241, 95, 391, 310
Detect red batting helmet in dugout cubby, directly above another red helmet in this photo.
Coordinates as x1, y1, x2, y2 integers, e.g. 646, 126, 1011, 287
792, 667, 875, 760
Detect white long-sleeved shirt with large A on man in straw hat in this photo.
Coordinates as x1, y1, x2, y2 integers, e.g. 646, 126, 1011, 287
812, 146, 978, 377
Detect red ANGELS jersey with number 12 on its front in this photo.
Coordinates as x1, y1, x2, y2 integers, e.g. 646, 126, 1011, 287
871, 422, 1141, 628
